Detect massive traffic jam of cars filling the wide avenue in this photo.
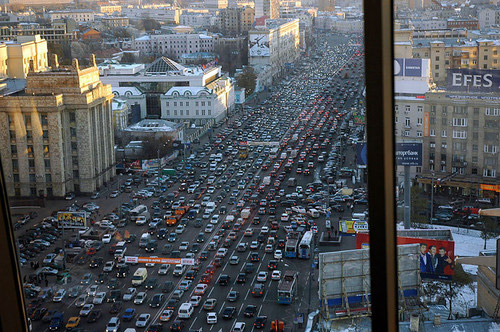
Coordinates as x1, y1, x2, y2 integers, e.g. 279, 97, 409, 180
21, 34, 366, 332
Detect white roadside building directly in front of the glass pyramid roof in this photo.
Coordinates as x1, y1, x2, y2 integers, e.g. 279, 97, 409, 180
161, 77, 236, 126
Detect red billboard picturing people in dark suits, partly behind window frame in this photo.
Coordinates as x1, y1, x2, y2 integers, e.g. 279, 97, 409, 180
356, 233, 455, 280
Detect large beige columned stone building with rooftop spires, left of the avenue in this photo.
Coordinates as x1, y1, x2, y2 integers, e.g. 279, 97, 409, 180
0, 58, 115, 197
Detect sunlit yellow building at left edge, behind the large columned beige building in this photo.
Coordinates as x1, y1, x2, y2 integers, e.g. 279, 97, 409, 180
0, 36, 48, 78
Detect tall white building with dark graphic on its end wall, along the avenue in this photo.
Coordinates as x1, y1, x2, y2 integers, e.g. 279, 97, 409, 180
248, 19, 300, 88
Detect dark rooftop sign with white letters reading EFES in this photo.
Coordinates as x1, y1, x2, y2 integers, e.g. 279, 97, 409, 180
447, 69, 500, 93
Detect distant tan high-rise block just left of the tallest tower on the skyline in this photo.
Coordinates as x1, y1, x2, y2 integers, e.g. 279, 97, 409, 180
217, 7, 255, 36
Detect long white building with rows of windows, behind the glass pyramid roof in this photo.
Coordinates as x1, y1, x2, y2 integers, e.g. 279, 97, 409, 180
132, 33, 215, 57
